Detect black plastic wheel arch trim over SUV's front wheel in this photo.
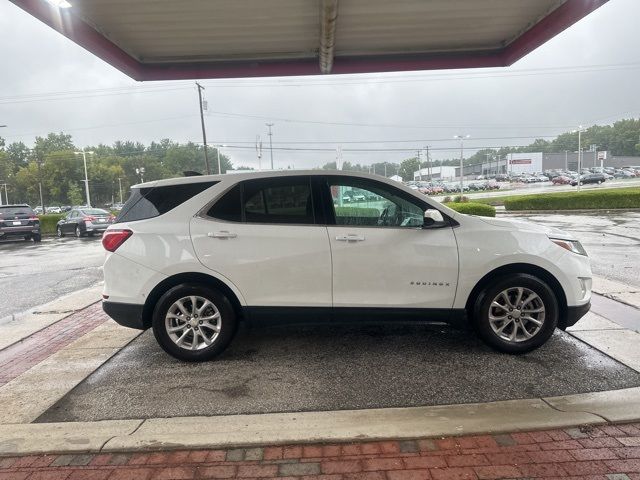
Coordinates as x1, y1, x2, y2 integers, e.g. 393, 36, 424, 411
465, 263, 568, 330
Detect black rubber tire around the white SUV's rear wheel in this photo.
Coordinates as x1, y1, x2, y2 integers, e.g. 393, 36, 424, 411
152, 284, 237, 362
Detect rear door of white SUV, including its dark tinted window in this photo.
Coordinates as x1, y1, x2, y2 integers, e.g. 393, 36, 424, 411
191, 176, 331, 308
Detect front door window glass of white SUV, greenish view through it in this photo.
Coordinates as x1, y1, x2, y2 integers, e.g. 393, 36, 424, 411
329, 178, 424, 228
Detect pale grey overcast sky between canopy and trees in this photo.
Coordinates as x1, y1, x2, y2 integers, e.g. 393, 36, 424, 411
0, 0, 640, 168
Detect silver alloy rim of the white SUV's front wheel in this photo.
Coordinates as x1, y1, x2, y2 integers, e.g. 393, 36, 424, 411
489, 287, 546, 343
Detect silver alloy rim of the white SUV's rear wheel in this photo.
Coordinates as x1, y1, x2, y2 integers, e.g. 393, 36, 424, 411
164, 295, 222, 350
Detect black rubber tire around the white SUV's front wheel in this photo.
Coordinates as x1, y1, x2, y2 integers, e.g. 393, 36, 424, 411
473, 273, 559, 354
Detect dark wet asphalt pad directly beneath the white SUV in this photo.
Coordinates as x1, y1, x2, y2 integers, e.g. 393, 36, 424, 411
37, 324, 640, 422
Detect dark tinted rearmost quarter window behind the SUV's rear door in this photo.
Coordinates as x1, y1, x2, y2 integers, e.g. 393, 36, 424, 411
115, 182, 217, 223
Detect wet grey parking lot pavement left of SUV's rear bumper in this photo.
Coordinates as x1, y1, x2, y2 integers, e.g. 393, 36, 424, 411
0, 237, 104, 320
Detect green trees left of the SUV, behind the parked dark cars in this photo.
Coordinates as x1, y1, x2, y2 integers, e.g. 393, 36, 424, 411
0, 133, 233, 206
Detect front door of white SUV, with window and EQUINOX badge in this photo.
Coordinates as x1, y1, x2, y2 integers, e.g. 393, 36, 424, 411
324, 176, 458, 311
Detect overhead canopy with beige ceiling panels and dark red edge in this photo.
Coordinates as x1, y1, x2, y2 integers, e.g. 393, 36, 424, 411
12, 0, 607, 80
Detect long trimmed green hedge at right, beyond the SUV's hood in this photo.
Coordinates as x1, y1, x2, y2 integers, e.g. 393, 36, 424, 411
504, 188, 640, 211
